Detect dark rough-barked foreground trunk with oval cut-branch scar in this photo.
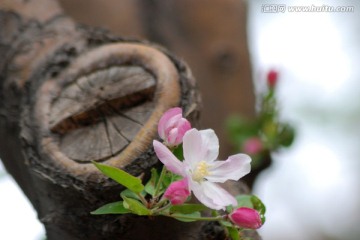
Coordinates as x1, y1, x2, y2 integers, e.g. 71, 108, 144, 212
0, 0, 258, 240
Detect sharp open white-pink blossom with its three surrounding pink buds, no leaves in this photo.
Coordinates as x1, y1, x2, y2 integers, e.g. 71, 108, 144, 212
153, 108, 262, 229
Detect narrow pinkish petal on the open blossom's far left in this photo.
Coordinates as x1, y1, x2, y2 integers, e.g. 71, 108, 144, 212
153, 140, 186, 177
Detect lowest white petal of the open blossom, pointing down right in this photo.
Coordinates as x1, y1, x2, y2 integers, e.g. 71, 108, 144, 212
189, 180, 237, 210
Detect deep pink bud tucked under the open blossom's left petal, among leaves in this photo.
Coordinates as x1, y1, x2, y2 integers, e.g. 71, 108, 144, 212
164, 178, 190, 205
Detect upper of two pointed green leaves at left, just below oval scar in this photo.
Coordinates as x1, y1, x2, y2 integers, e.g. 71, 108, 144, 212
93, 162, 144, 193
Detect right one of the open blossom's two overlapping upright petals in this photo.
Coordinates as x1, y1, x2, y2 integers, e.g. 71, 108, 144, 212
200, 129, 219, 162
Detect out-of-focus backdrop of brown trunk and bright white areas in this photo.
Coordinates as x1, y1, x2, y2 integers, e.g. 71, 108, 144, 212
0, 0, 360, 240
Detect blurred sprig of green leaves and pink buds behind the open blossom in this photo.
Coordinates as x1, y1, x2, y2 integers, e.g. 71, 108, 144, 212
227, 69, 295, 187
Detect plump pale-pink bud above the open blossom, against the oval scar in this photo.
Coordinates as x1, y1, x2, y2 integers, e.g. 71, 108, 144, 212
158, 107, 191, 147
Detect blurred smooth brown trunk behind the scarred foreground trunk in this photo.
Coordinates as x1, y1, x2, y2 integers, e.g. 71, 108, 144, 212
59, 0, 264, 187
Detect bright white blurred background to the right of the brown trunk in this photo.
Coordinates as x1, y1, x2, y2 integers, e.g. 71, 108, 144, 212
248, 0, 360, 240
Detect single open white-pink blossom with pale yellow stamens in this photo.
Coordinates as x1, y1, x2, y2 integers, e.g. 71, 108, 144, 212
153, 128, 251, 210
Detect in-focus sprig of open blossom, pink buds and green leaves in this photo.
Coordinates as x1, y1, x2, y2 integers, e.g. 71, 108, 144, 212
92, 108, 265, 239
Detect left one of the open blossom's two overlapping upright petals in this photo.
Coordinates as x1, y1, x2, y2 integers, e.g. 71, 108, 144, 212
183, 128, 204, 169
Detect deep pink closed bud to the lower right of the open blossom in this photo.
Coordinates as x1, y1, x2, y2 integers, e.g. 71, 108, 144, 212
229, 207, 262, 229
